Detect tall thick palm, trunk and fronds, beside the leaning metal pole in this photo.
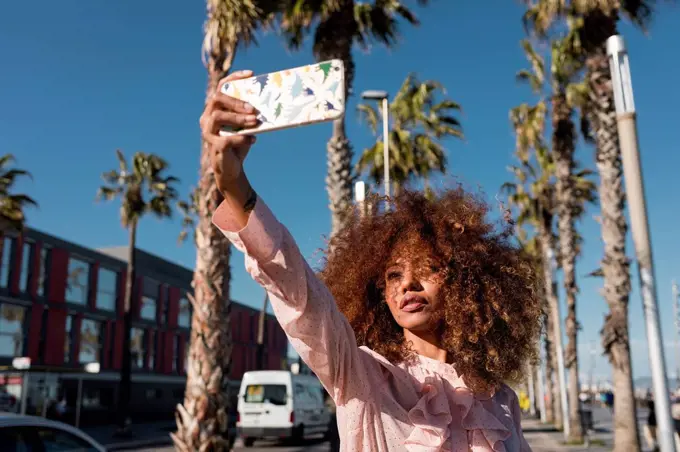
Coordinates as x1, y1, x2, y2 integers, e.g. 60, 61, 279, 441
524, 0, 656, 452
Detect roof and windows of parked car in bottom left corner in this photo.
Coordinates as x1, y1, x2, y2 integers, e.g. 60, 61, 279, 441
0, 413, 106, 452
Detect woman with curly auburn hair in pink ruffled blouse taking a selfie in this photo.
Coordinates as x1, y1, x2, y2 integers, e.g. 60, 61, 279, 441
201, 71, 541, 452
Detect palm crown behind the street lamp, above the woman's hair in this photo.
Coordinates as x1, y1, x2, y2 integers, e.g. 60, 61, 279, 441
356, 74, 463, 195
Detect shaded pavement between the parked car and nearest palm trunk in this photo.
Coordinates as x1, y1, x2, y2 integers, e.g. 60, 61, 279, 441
82, 421, 177, 451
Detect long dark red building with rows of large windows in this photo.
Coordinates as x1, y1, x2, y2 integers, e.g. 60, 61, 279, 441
0, 229, 287, 426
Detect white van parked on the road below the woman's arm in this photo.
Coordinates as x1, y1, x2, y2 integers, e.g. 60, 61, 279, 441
236, 370, 330, 447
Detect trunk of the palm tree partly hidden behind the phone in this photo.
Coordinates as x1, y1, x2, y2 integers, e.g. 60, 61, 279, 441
315, 0, 356, 237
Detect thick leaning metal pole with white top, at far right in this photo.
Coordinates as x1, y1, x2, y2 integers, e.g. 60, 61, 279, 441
607, 36, 675, 452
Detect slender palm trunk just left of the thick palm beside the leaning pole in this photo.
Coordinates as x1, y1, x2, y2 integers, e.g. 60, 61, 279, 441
552, 92, 583, 442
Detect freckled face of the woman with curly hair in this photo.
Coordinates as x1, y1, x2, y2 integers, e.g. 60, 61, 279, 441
385, 259, 443, 333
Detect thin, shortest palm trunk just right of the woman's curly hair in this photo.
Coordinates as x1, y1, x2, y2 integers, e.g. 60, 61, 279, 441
539, 222, 564, 429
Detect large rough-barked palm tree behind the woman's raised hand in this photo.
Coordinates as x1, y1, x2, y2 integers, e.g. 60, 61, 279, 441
171, 0, 280, 451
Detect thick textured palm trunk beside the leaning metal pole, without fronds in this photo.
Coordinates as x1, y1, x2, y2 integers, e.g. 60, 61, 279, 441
586, 35, 640, 452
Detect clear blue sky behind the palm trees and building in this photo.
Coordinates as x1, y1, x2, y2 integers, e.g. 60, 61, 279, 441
0, 0, 680, 382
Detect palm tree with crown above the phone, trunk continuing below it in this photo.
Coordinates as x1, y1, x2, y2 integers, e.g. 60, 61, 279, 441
281, 0, 427, 236
